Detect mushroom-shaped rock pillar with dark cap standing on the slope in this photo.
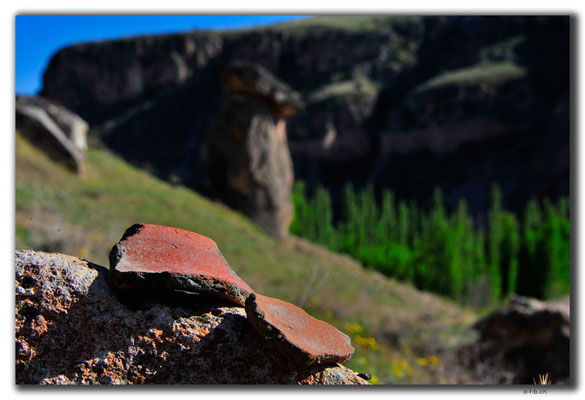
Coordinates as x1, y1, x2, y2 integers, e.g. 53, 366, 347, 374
206, 62, 303, 239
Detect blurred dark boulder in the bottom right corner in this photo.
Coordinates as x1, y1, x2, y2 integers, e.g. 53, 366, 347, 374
460, 296, 571, 384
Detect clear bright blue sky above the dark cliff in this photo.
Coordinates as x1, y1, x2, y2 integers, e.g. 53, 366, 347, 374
15, 15, 303, 95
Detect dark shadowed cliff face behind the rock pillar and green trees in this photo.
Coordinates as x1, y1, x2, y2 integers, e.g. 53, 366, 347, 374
42, 16, 570, 218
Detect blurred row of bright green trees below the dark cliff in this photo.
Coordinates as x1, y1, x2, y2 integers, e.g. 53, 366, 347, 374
291, 182, 571, 309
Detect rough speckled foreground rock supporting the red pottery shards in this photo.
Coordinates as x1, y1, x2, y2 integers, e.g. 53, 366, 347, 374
15, 250, 367, 385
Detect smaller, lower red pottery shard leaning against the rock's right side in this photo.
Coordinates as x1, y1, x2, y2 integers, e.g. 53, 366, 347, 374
246, 293, 354, 365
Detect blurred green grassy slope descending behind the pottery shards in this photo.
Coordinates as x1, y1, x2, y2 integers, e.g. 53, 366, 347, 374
15, 134, 474, 383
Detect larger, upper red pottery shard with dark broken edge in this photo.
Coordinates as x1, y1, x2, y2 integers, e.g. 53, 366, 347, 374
108, 224, 254, 306
